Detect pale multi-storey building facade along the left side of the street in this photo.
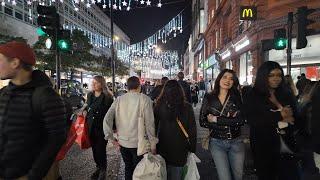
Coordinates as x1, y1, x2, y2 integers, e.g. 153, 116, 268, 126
0, 0, 130, 56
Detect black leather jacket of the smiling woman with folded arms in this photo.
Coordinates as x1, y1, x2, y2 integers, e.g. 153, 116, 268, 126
199, 94, 244, 139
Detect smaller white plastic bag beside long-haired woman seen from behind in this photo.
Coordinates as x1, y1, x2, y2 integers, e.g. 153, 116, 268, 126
184, 153, 201, 180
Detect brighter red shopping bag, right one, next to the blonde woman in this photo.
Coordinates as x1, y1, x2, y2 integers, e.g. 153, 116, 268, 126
75, 116, 91, 149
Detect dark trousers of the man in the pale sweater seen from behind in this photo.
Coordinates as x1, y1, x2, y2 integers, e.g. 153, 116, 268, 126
120, 146, 143, 180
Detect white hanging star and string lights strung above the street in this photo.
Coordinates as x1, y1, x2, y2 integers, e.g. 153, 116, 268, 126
0, 0, 183, 73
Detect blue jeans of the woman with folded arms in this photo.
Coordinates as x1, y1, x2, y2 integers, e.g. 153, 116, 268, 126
209, 138, 245, 180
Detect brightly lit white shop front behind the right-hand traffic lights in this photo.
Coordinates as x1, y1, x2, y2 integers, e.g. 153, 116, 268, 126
268, 35, 320, 81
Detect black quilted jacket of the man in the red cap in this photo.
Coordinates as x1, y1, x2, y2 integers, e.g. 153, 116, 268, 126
0, 71, 67, 180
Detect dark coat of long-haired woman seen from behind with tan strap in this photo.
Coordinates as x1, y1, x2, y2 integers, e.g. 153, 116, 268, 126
154, 103, 197, 167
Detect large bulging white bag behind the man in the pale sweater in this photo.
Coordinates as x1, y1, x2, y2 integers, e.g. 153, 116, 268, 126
133, 153, 167, 180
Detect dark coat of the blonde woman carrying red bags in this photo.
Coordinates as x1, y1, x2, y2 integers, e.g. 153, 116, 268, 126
86, 92, 113, 137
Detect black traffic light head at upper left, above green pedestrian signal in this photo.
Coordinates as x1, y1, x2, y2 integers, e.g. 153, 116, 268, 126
37, 5, 60, 37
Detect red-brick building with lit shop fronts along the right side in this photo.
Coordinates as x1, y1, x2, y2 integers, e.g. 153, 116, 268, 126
204, 0, 320, 84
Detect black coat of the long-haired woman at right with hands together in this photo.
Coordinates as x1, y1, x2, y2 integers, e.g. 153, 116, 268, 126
242, 88, 297, 179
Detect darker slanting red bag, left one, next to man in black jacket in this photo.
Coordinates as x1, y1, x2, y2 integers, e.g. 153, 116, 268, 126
56, 123, 77, 161
